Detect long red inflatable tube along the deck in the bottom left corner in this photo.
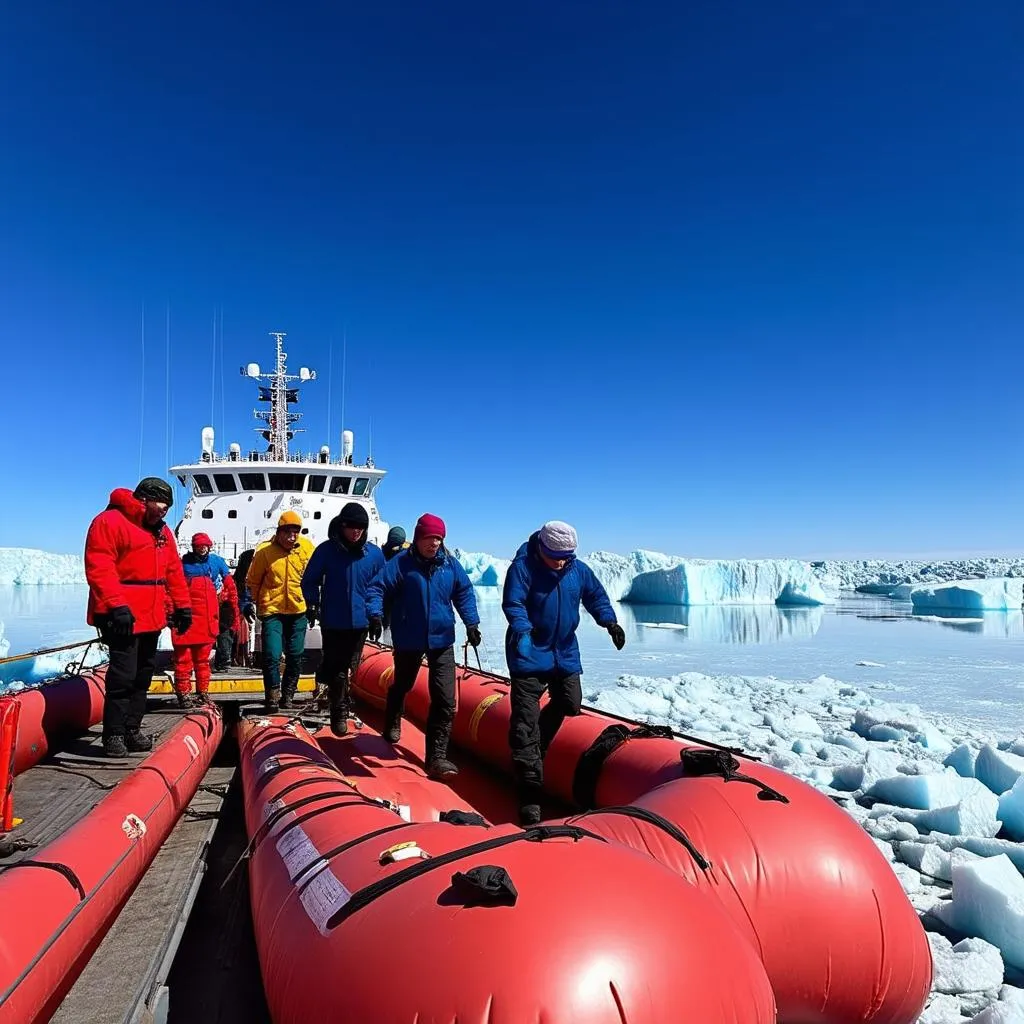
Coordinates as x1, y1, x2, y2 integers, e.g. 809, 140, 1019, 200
0, 704, 223, 1024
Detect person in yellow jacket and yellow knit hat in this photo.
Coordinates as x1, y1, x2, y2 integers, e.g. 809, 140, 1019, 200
246, 510, 313, 715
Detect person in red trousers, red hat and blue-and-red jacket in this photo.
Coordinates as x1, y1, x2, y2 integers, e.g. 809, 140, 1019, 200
171, 534, 230, 710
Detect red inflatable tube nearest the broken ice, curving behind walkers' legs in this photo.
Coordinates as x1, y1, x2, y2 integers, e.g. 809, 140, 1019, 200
353, 645, 932, 1024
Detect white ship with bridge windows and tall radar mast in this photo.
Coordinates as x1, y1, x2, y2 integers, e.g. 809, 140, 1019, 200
170, 332, 389, 566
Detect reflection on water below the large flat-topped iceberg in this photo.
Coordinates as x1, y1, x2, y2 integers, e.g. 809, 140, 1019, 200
618, 604, 824, 643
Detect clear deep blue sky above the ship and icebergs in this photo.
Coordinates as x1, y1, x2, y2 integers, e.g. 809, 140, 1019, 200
0, 0, 1024, 557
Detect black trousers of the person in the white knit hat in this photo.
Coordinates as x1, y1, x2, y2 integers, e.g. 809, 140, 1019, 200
509, 672, 583, 786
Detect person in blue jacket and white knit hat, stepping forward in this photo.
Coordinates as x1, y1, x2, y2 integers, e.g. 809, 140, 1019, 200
502, 519, 626, 825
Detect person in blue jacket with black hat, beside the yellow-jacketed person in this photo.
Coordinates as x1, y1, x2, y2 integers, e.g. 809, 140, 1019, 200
302, 502, 384, 736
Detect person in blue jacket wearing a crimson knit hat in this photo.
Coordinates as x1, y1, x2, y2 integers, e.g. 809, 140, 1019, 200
370, 514, 480, 778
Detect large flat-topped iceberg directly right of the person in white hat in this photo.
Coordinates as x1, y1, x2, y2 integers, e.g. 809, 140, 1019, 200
623, 558, 831, 606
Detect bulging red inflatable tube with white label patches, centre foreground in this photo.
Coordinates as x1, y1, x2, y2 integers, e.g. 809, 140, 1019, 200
239, 718, 776, 1024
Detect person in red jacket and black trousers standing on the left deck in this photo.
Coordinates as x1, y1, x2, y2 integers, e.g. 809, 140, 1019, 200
85, 476, 191, 758
